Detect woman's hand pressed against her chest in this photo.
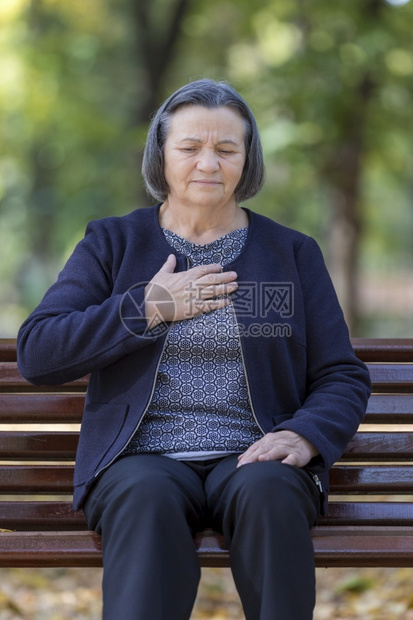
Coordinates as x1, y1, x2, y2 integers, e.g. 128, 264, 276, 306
145, 254, 238, 329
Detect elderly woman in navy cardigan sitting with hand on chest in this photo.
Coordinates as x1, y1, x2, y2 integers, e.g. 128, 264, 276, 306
18, 80, 369, 620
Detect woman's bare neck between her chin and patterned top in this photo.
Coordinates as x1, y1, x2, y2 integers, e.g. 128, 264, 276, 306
159, 200, 248, 244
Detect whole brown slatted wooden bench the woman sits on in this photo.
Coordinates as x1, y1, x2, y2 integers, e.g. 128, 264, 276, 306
0, 339, 413, 567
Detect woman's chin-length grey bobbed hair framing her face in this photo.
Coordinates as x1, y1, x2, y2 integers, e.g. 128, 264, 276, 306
142, 79, 264, 202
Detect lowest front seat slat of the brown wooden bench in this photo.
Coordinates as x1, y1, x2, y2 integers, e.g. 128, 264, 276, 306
0, 527, 413, 567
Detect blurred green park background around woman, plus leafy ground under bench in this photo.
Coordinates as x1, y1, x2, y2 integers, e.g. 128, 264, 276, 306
0, 0, 413, 620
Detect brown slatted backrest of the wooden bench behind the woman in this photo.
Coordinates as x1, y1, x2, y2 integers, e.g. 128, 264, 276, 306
0, 339, 413, 531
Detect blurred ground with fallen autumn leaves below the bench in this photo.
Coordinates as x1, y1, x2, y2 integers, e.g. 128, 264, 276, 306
0, 568, 413, 620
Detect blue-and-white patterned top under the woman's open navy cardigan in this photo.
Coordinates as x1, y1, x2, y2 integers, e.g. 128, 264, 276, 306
124, 228, 262, 459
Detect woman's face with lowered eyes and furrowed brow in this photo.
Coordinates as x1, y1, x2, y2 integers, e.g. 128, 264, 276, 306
164, 105, 245, 207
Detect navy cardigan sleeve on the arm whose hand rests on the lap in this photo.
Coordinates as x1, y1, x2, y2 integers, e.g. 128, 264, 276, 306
275, 237, 371, 471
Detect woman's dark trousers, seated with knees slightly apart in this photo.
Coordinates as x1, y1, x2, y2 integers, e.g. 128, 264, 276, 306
84, 454, 319, 620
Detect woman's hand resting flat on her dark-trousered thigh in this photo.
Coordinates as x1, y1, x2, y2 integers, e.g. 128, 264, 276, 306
238, 431, 318, 467
